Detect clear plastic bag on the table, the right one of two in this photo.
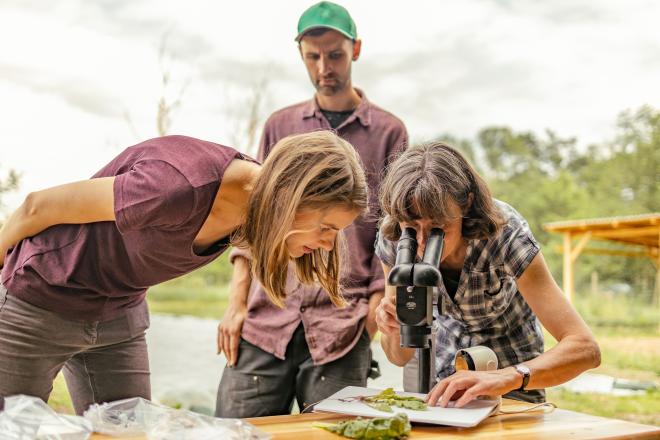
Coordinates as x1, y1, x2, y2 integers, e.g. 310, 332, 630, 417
84, 397, 270, 440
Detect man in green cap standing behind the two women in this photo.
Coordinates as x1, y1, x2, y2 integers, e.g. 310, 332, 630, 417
216, 1, 407, 417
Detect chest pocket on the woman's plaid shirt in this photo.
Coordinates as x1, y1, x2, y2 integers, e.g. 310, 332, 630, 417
461, 266, 518, 330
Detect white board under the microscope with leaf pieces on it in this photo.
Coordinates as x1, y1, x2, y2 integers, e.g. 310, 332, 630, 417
314, 387, 499, 428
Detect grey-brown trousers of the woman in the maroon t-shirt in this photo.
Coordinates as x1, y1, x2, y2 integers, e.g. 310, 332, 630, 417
0, 285, 151, 414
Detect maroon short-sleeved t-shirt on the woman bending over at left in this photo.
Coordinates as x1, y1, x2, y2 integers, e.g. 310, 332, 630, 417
1, 136, 249, 321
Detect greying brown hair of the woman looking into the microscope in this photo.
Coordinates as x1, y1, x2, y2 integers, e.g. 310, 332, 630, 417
380, 142, 504, 241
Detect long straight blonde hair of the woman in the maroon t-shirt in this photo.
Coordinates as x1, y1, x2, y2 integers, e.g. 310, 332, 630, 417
232, 131, 368, 307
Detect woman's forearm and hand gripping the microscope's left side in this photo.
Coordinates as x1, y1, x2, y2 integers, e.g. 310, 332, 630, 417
376, 264, 415, 367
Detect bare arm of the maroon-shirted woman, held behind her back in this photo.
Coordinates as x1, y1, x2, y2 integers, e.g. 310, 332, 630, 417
0, 177, 115, 267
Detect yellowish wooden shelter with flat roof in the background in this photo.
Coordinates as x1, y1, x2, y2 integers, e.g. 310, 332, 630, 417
543, 213, 660, 302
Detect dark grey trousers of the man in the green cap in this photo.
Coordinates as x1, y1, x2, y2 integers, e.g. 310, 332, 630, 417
215, 324, 371, 417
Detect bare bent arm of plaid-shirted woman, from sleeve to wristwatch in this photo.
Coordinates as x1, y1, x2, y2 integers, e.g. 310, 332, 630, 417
510, 252, 600, 389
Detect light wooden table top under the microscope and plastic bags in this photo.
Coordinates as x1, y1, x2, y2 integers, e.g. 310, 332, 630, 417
92, 399, 660, 440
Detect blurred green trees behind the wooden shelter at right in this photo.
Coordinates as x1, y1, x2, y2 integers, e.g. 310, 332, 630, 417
473, 106, 660, 300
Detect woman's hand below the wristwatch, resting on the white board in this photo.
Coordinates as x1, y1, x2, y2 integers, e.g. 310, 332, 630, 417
426, 367, 522, 408
